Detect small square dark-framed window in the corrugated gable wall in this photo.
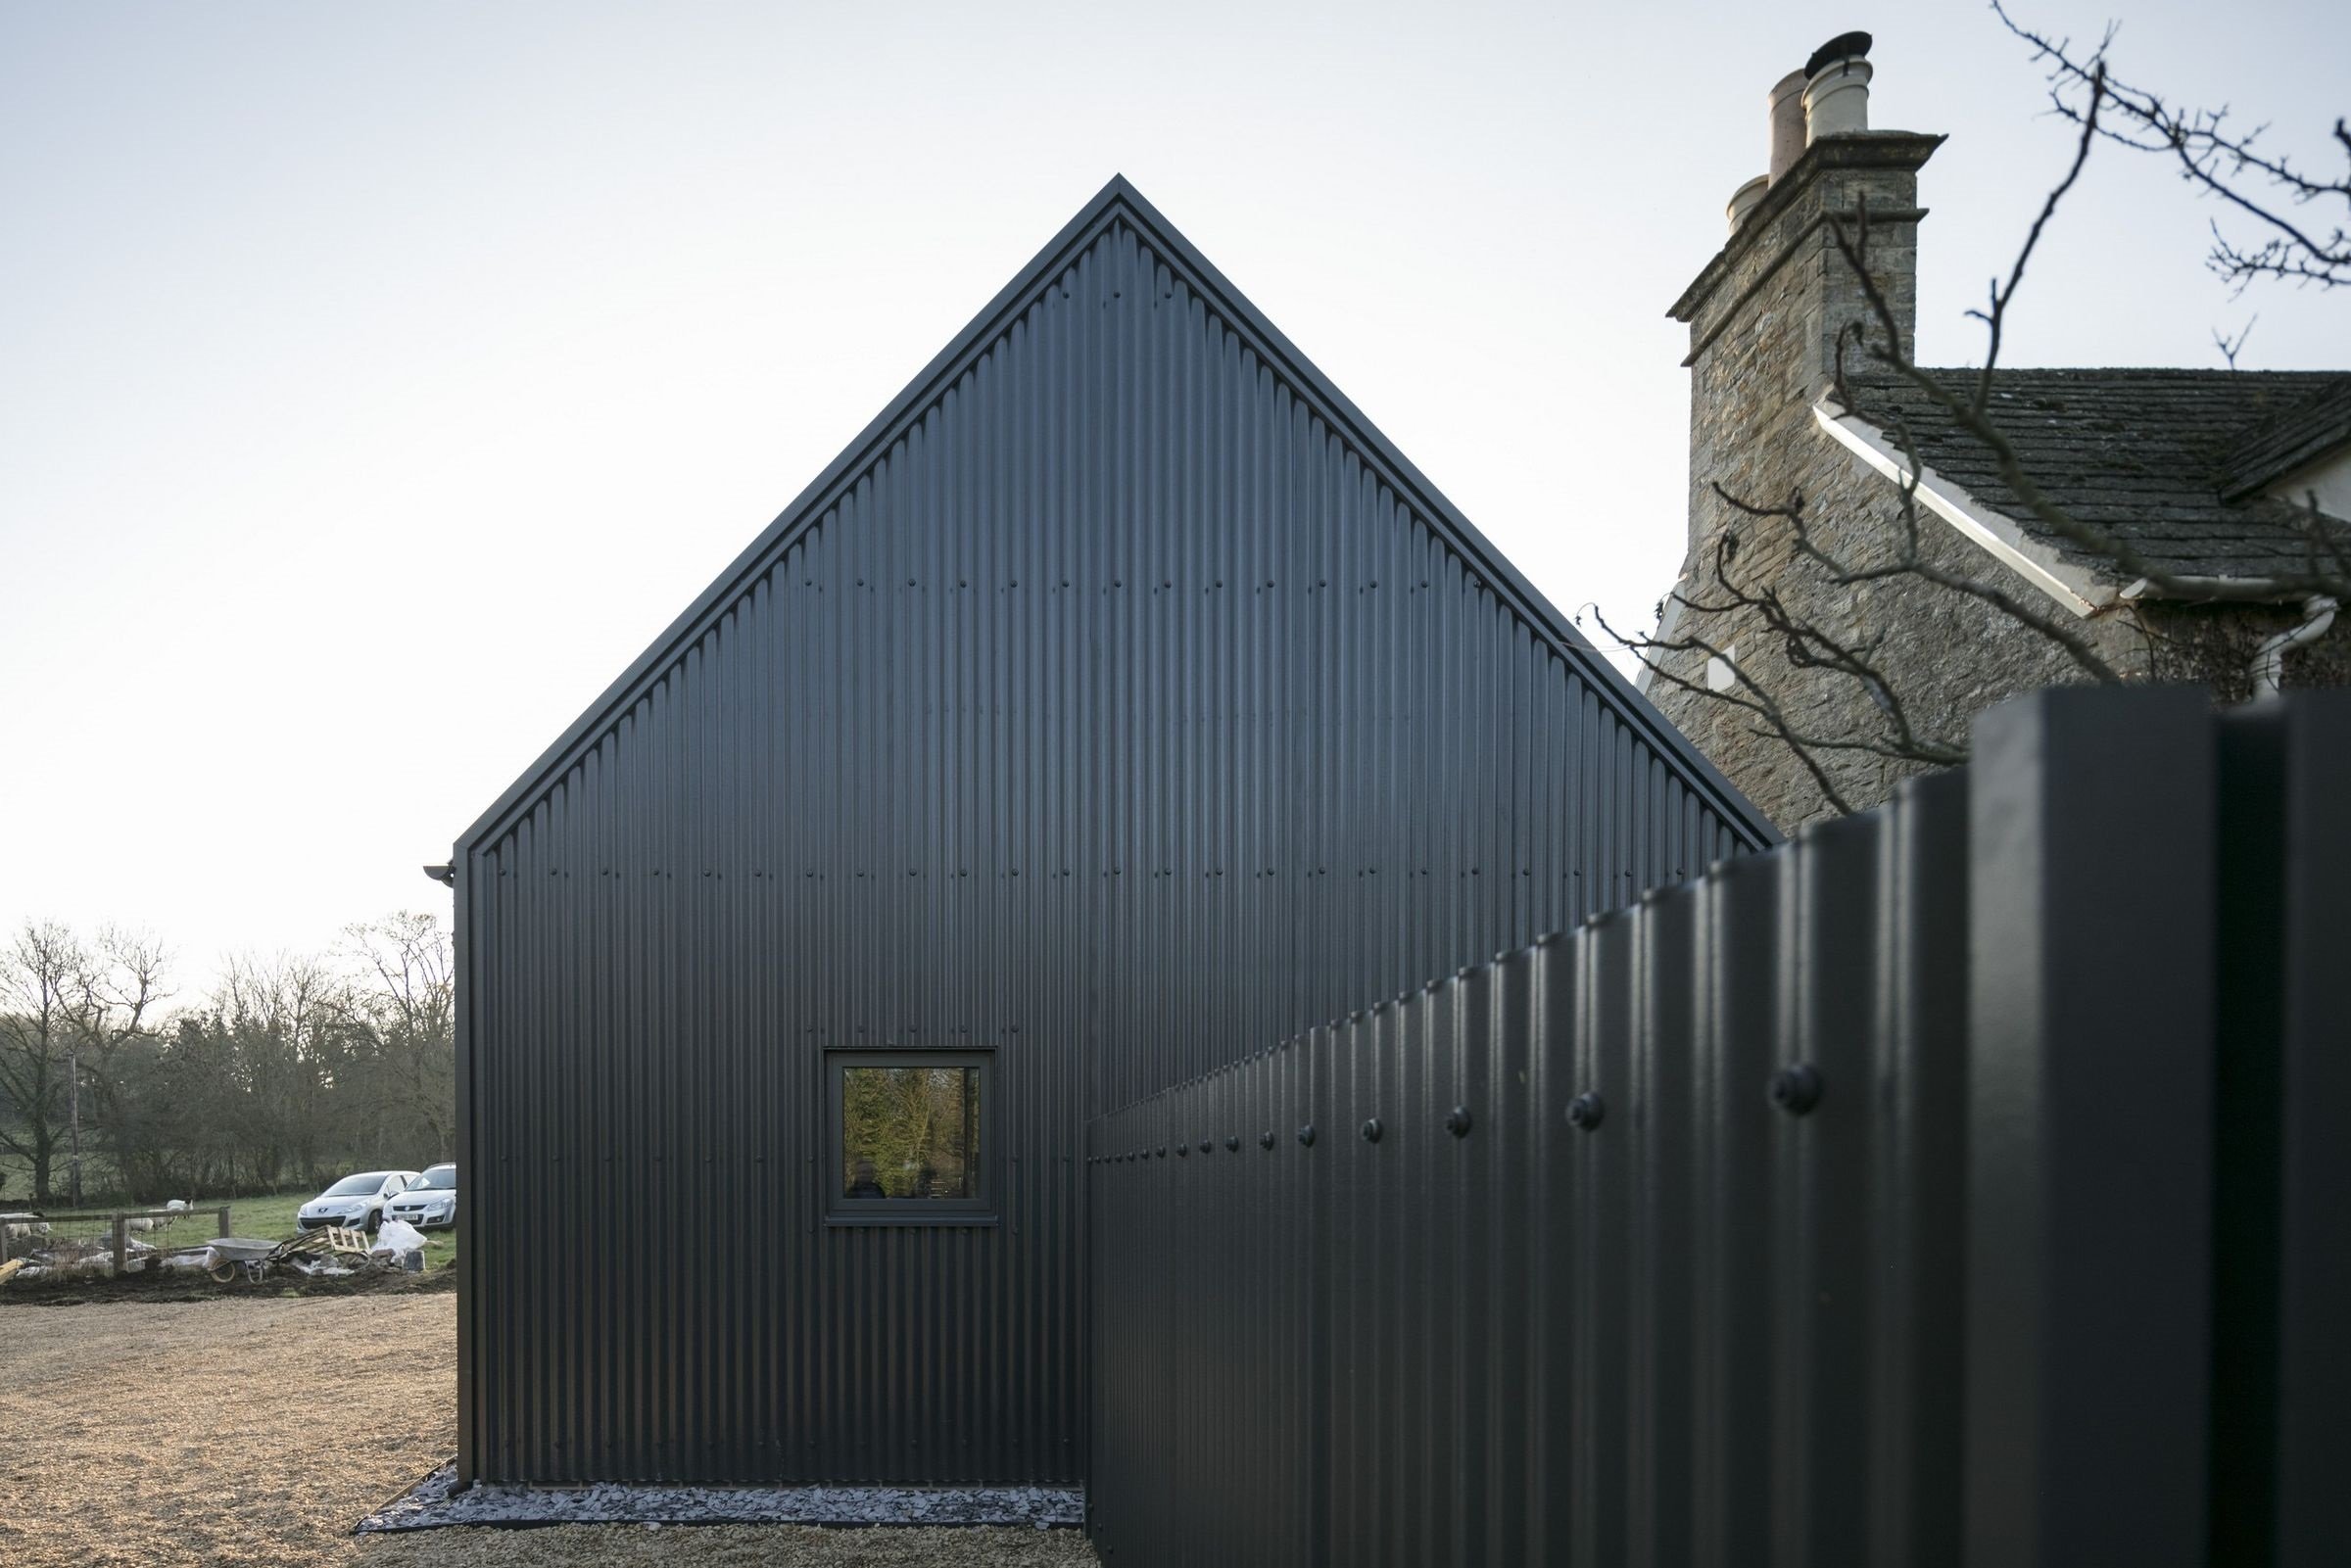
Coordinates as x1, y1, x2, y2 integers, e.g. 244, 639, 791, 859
825, 1051, 994, 1225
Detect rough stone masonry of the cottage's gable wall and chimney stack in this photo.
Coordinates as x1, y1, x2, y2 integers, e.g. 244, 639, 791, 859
1648, 131, 2323, 830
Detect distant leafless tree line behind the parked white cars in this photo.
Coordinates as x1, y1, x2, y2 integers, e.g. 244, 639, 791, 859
0, 915, 456, 1206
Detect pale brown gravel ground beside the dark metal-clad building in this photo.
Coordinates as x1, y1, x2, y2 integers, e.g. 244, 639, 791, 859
0, 1293, 1095, 1568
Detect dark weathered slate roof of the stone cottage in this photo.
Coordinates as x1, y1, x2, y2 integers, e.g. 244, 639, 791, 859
1852, 369, 2351, 586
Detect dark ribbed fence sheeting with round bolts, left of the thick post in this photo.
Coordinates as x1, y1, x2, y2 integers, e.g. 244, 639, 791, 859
1088, 778, 1965, 1568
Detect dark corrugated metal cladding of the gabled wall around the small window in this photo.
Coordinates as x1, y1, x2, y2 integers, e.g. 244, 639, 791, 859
458, 181, 1770, 1481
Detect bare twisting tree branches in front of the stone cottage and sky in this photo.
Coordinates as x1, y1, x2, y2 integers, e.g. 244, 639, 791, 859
1587, 18, 2351, 814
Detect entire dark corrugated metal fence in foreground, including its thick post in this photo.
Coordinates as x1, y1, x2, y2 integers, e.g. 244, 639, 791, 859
1088, 689, 2351, 1568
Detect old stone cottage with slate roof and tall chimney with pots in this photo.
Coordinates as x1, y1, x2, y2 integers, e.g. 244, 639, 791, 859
1644, 33, 2351, 830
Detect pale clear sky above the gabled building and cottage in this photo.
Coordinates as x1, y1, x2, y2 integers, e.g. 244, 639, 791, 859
0, 0, 2351, 994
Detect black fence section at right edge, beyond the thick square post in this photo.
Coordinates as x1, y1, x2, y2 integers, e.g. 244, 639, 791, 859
2212, 693, 2351, 1568
